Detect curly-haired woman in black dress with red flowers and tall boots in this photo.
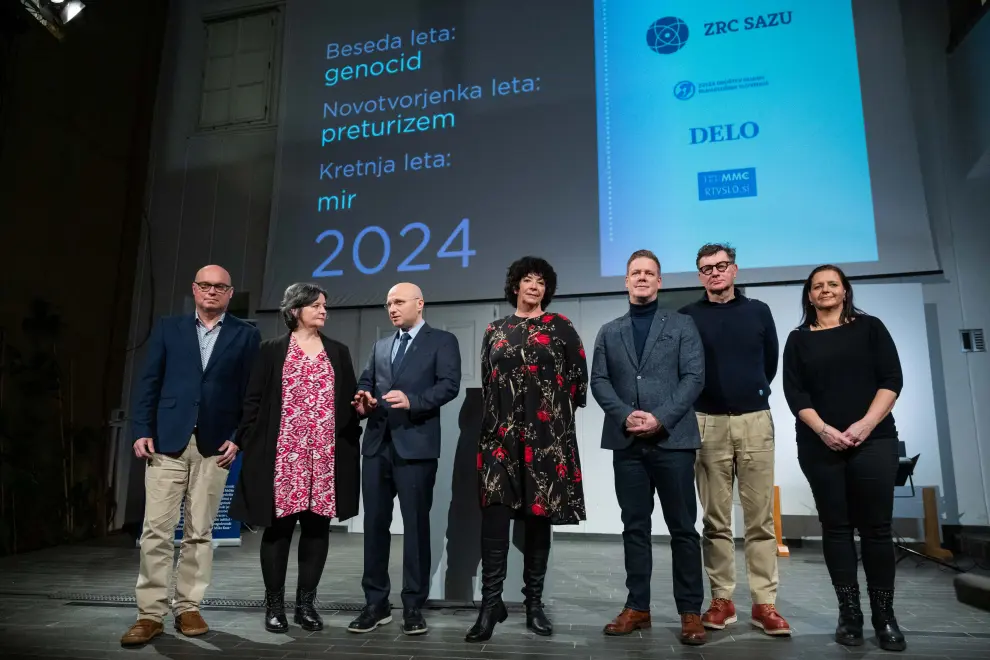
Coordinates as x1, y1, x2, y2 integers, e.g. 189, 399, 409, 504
466, 257, 588, 642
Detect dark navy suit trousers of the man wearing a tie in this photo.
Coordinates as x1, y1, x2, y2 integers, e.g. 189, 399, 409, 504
361, 441, 437, 610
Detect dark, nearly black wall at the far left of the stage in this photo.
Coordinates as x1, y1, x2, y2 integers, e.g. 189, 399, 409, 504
0, 0, 168, 552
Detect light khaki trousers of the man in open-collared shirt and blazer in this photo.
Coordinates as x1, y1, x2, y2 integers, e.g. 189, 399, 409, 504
134, 435, 228, 622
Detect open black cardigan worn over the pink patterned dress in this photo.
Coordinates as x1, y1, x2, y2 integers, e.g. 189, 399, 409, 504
230, 333, 361, 527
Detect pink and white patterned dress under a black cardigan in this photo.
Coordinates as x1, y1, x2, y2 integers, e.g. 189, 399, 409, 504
275, 336, 337, 518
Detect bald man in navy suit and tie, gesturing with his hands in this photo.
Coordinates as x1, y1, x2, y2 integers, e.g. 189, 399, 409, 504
347, 283, 461, 635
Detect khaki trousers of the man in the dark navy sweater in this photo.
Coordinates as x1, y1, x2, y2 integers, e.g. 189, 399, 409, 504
695, 410, 779, 605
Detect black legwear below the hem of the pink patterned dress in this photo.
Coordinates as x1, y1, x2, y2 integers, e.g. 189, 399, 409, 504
261, 511, 330, 593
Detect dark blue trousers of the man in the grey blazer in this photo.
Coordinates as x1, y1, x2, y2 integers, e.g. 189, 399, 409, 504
612, 439, 705, 614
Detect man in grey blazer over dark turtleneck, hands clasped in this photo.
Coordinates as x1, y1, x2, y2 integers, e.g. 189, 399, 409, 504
591, 250, 705, 645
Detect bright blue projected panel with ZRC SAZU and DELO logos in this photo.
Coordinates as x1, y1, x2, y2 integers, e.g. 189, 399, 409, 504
595, 0, 877, 276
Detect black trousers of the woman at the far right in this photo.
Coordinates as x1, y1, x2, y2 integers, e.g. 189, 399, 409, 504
798, 437, 898, 589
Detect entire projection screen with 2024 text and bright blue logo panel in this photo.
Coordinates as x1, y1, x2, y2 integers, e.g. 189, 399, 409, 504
261, 0, 938, 309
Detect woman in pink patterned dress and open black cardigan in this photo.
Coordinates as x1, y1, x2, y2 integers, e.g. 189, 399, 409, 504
231, 284, 361, 632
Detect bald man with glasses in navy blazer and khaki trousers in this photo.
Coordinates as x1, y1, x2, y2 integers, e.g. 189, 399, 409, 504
120, 266, 261, 646
